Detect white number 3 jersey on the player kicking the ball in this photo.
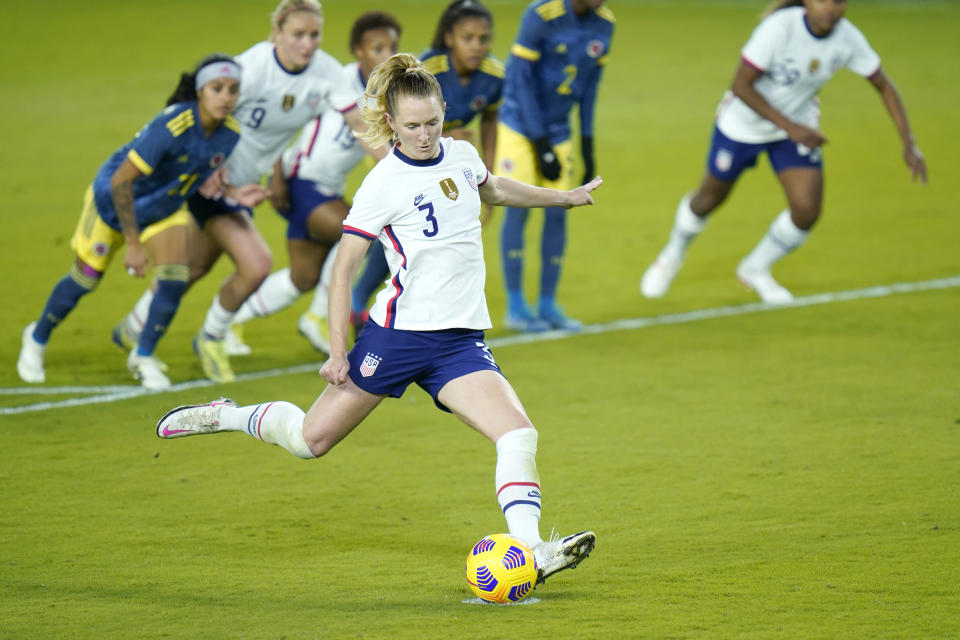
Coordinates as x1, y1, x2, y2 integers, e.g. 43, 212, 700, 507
343, 138, 491, 331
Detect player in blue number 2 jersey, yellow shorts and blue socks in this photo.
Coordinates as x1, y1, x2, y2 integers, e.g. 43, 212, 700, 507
496, 0, 614, 331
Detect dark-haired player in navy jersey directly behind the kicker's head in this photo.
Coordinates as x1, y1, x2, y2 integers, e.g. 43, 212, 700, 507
348, 0, 504, 340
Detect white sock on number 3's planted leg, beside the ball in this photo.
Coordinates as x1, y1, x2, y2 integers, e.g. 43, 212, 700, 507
496, 428, 541, 548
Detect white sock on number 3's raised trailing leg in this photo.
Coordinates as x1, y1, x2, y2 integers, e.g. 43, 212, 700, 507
220, 402, 316, 460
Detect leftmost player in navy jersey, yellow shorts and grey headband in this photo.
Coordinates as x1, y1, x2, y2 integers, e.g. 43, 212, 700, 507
17, 54, 267, 389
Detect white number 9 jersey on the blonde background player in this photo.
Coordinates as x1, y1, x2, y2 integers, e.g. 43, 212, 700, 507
227, 42, 357, 185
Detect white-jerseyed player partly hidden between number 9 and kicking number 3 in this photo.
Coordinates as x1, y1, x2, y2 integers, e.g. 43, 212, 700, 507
226, 11, 402, 355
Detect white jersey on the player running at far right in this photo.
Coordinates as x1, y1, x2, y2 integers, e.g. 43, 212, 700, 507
717, 7, 880, 143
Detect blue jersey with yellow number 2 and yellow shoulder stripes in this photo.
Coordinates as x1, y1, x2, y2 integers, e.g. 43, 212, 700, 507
500, 0, 614, 144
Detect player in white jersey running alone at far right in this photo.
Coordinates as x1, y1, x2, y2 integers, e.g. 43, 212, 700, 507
640, 0, 927, 304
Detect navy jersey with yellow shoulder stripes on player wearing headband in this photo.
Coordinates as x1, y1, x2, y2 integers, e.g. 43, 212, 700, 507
93, 101, 240, 231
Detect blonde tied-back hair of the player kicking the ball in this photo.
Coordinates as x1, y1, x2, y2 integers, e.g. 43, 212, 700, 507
360, 53, 443, 148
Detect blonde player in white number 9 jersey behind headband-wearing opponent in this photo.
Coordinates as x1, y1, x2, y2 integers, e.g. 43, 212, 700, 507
114, 0, 378, 382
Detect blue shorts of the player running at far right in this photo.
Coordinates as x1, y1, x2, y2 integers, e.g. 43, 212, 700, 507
707, 125, 823, 182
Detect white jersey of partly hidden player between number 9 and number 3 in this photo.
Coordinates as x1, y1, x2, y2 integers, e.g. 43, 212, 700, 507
283, 62, 366, 196
